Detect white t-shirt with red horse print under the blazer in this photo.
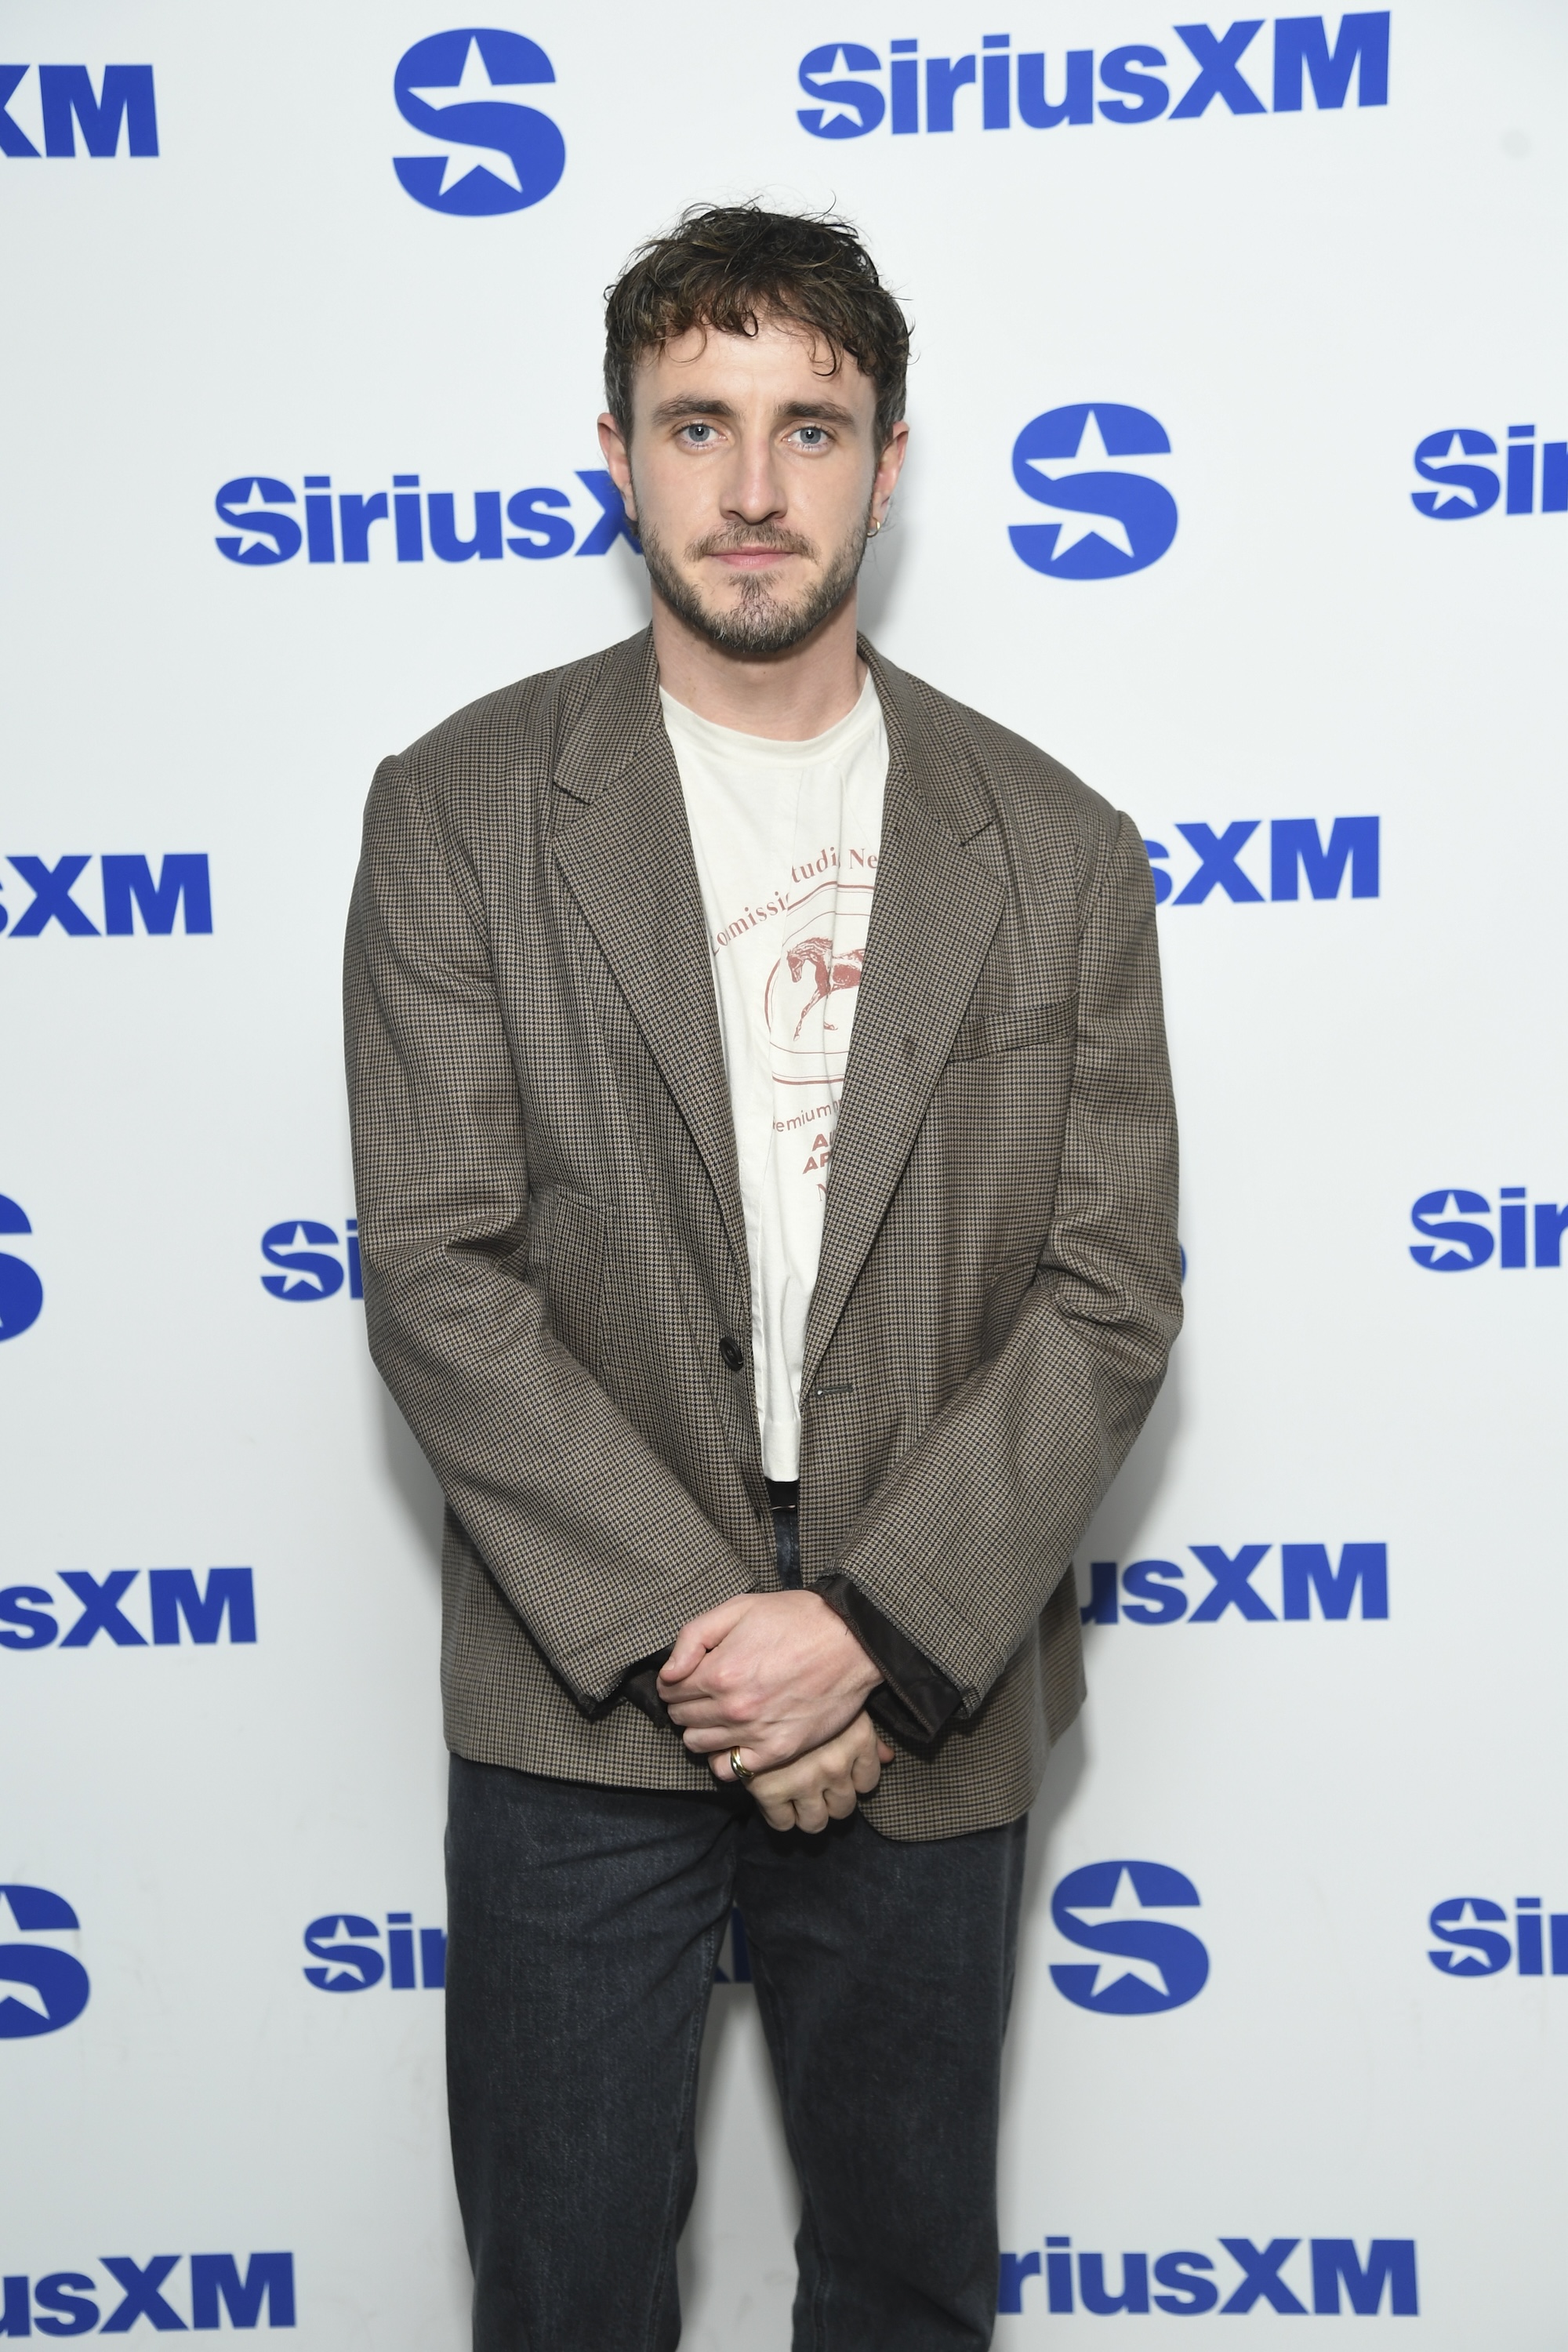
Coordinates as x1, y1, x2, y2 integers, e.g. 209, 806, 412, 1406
659, 677, 888, 1479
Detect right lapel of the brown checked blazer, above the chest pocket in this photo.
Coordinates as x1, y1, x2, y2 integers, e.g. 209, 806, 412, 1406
801, 642, 1006, 1395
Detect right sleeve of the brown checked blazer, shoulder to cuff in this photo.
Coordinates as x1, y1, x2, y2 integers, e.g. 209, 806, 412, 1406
834, 816, 1182, 1715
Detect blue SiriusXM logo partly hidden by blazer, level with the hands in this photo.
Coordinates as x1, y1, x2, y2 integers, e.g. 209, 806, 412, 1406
1079, 1543, 1389, 1625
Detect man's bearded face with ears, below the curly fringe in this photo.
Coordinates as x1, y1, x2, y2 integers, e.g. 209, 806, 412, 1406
600, 322, 907, 656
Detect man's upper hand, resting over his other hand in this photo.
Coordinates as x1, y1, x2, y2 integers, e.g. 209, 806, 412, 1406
659, 1592, 881, 1778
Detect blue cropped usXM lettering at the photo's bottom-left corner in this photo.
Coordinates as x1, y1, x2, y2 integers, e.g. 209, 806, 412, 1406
0, 2253, 294, 2336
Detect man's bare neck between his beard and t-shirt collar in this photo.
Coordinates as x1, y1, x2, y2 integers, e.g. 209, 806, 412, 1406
654, 588, 865, 743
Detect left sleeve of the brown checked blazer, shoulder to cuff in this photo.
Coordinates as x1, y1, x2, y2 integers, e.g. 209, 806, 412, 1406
343, 760, 755, 1715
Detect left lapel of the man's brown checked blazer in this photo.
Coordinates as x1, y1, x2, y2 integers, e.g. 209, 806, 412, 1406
555, 633, 752, 1277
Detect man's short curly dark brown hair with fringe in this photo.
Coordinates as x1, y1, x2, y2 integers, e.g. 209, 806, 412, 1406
604, 202, 909, 449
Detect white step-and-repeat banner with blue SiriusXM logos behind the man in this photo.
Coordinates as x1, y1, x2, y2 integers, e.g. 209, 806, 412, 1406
0, 0, 1568, 2352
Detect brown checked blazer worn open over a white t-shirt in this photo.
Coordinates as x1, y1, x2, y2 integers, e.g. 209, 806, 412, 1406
346, 633, 1180, 1839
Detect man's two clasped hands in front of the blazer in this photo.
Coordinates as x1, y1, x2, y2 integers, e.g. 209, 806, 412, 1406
659, 1592, 893, 1830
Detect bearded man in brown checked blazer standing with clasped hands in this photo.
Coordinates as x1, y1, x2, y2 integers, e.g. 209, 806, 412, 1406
348, 205, 1180, 2352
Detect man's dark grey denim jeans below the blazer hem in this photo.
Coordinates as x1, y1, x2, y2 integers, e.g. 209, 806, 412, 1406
447, 1757, 1025, 2352
